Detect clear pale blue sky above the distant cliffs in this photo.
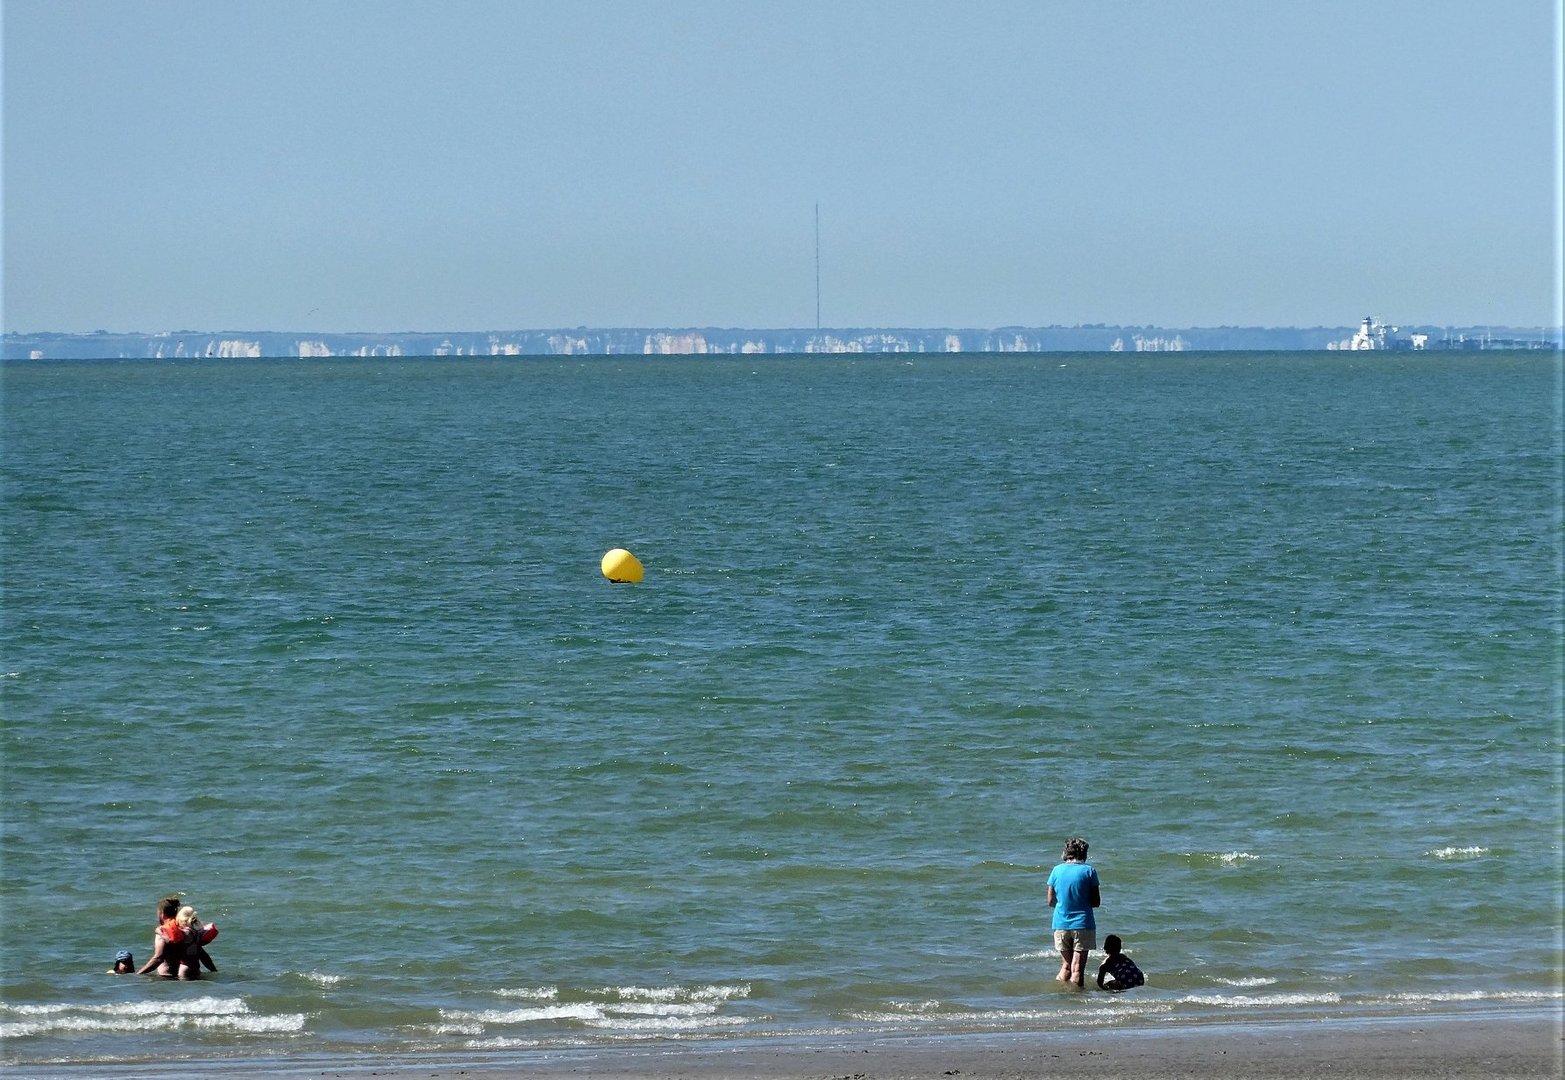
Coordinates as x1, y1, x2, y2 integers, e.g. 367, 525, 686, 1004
0, 0, 1560, 332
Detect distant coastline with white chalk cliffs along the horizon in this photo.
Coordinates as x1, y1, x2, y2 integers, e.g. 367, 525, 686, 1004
0, 318, 1562, 360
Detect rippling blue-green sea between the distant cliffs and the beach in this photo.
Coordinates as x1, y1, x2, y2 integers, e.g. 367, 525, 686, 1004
0, 352, 1565, 1075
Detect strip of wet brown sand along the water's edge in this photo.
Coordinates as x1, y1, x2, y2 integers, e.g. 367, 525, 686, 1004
24, 1006, 1565, 1080
